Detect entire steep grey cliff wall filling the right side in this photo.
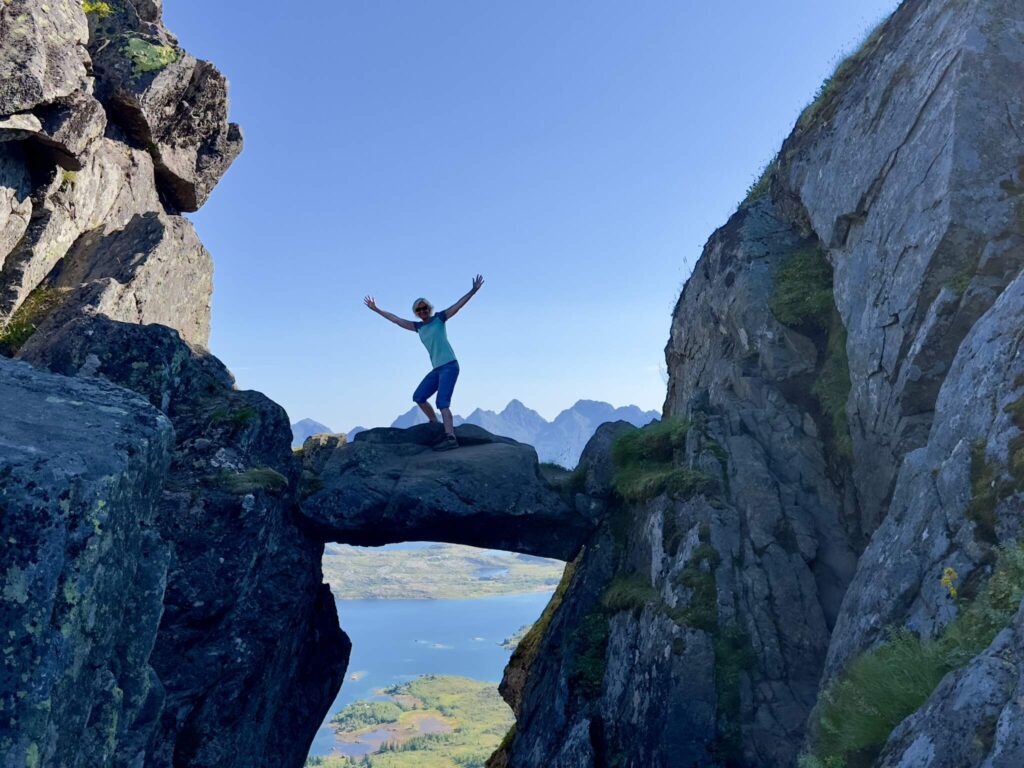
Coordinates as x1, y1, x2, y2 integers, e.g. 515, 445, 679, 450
501, 0, 1024, 768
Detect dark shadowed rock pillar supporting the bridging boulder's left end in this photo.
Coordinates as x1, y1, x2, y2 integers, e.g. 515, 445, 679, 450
22, 317, 349, 766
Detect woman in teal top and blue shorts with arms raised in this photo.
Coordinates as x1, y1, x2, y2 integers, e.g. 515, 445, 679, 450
362, 274, 483, 451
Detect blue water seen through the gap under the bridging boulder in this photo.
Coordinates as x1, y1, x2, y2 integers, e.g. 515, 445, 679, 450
309, 592, 551, 755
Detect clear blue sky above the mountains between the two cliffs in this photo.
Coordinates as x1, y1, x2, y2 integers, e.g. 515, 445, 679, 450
165, 0, 897, 430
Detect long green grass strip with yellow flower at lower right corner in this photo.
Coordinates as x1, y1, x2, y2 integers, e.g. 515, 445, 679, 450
805, 545, 1024, 766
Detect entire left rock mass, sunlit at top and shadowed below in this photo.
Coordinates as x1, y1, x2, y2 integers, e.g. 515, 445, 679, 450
0, 0, 349, 768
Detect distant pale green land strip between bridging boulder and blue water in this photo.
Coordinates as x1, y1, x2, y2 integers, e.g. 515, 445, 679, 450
324, 544, 565, 600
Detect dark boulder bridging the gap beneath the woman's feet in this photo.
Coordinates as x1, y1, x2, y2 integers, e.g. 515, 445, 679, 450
302, 424, 596, 560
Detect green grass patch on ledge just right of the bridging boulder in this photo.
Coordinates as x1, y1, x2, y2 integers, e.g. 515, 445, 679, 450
611, 417, 708, 504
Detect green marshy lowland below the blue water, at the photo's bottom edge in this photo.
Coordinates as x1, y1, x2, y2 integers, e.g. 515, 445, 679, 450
306, 675, 514, 768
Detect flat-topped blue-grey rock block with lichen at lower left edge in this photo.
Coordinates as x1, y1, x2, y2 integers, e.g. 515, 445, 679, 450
0, 357, 173, 766
